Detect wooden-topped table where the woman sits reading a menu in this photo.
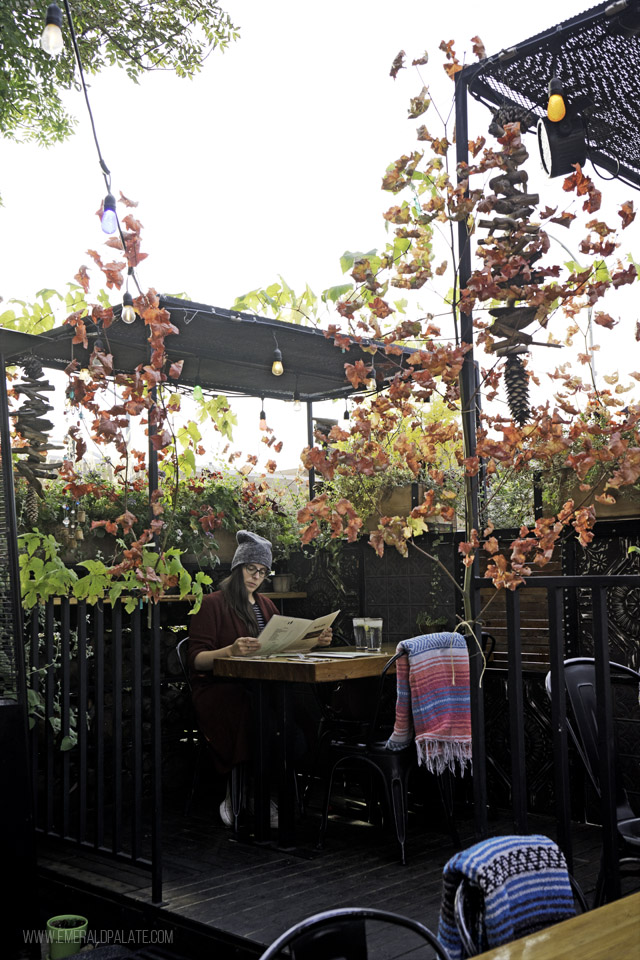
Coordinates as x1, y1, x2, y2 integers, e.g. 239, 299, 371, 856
213, 647, 396, 850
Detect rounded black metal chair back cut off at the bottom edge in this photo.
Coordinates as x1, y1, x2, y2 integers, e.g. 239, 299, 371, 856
260, 907, 450, 960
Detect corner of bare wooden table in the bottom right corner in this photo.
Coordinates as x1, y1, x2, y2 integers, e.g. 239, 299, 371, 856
476, 893, 640, 960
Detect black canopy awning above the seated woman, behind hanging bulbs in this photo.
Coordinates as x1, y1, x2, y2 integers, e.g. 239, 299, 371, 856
0, 297, 413, 401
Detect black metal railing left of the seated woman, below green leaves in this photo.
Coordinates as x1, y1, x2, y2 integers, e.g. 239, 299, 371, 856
27, 598, 162, 902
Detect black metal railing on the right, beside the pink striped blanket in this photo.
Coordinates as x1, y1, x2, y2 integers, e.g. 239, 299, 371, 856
470, 574, 640, 900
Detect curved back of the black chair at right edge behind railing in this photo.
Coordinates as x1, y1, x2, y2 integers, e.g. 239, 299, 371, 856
545, 657, 640, 820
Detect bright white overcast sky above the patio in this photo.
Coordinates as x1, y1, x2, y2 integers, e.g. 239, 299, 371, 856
0, 0, 640, 466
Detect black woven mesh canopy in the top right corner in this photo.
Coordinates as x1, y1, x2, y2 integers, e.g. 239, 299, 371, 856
463, 0, 640, 188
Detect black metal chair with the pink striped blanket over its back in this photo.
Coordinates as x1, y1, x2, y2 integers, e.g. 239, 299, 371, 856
318, 652, 459, 864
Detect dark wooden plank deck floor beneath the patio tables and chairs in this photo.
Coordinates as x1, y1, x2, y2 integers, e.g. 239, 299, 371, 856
33, 780, 626, 960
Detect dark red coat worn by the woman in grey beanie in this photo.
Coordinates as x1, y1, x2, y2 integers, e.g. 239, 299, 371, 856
187, 590, 278, 774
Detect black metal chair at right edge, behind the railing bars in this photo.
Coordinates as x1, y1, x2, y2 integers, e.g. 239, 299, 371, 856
545, 657, 640, 906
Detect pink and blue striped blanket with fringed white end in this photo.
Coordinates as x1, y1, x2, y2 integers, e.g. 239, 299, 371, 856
387, 633, 471, 773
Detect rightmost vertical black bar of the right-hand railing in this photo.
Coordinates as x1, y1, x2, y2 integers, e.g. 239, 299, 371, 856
592, 586, 620, 900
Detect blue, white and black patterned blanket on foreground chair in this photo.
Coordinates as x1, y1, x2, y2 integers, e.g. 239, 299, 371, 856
438, 834, 575, 960
